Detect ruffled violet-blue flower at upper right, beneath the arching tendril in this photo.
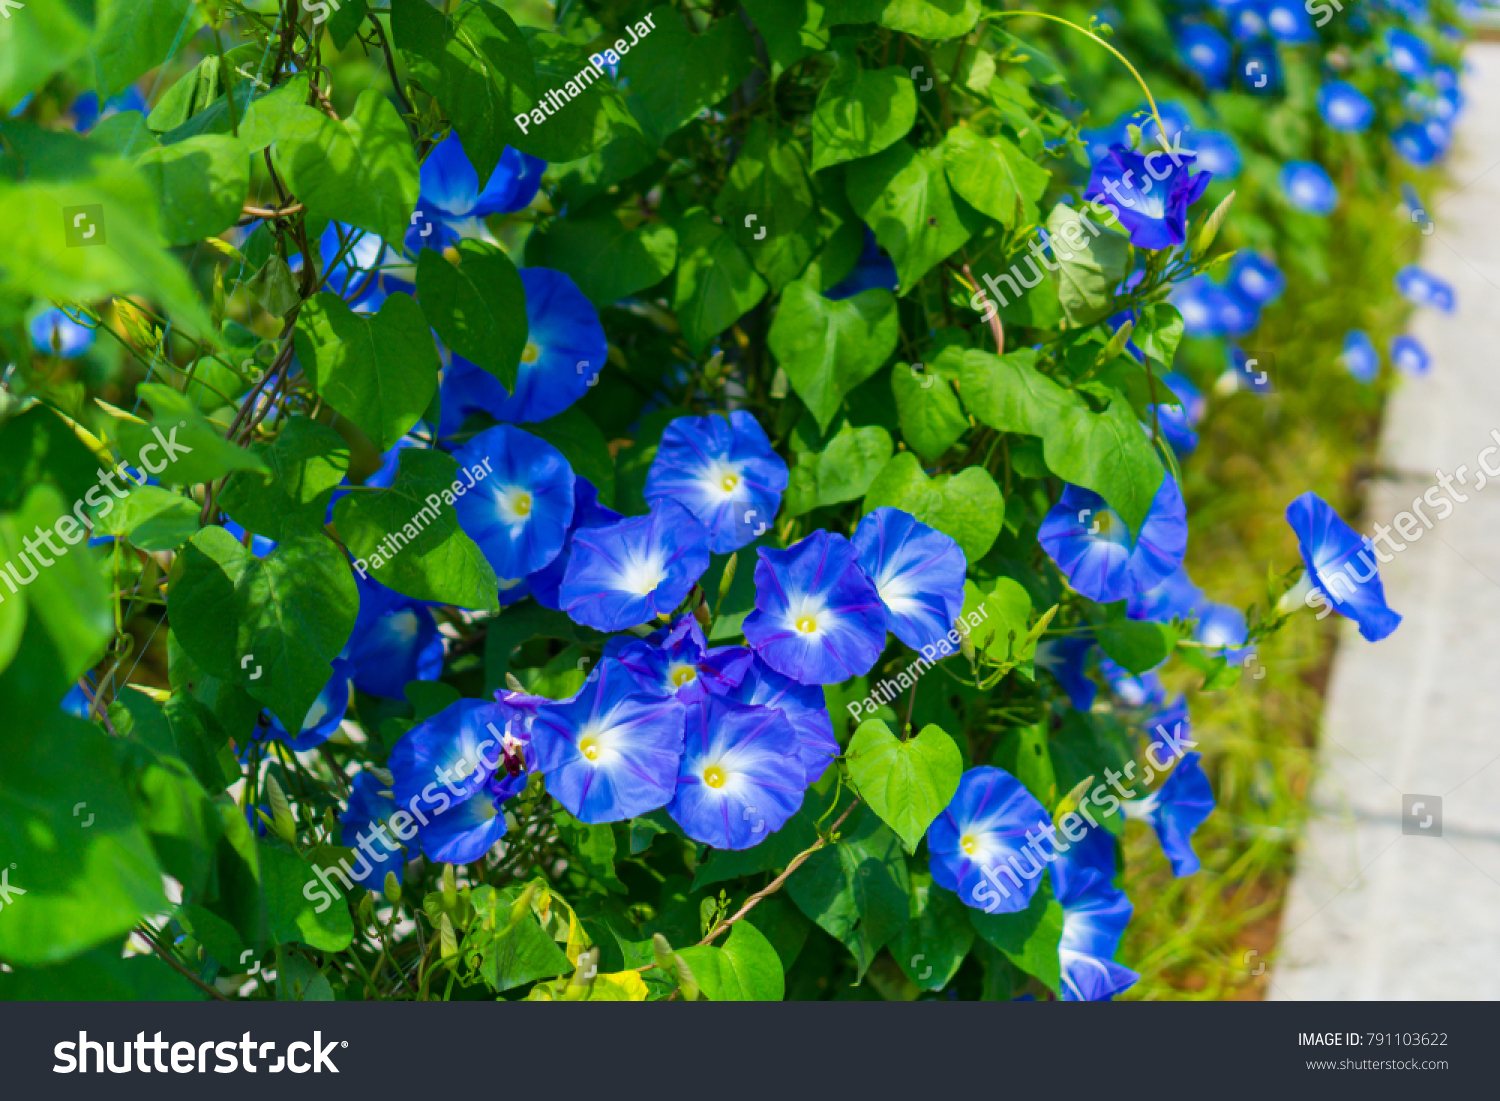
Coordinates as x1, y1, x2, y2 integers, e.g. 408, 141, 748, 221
1083, 146, 1211, 249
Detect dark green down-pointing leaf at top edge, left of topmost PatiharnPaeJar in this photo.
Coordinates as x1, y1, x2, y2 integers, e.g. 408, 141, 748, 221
390, 0, 546, 180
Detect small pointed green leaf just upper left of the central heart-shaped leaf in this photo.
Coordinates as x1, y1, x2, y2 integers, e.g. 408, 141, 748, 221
674, 208, 768, 353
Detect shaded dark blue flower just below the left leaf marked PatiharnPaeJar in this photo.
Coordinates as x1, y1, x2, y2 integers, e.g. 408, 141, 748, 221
342, 572, 443, 699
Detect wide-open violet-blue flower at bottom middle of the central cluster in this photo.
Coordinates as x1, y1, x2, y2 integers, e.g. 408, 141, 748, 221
666, 696, 807, 849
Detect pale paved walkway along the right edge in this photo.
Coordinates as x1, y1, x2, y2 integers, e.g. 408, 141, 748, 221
1269, 44, 1500, 999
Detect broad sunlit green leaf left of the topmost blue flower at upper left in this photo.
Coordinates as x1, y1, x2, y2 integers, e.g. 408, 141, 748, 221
272, 89, 420, 242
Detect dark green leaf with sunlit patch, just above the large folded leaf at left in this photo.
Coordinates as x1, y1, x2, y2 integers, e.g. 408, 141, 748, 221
217, 417, 350, 546
